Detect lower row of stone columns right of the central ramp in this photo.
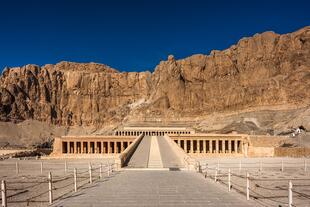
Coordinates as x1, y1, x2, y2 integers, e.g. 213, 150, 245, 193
171, 137, 245, 154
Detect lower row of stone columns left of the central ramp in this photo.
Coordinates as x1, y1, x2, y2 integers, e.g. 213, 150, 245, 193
61, 139, 133, 154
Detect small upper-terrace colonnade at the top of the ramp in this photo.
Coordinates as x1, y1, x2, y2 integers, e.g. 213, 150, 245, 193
115, 130, 191, 136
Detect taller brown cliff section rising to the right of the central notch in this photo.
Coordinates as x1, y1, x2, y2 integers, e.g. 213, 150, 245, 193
151, 27, 310, 115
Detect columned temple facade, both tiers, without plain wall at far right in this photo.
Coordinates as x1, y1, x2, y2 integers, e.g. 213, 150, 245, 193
52, 127, 249, 157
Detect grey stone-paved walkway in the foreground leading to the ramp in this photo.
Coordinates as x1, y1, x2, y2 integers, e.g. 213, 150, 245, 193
53, 171, 255, 207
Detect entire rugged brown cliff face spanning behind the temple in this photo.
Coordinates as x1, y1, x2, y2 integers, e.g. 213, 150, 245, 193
0, 27, 310, 129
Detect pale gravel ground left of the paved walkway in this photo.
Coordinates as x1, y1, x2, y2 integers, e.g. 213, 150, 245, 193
0, 159, 114, 207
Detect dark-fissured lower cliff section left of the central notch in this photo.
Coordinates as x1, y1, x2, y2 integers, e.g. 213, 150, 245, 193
0, 62, 151, 125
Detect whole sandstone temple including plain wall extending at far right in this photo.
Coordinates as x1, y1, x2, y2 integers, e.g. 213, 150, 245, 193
51, 126, 298, 165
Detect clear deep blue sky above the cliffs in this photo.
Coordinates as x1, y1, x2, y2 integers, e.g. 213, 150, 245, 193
0, 0, 310, 71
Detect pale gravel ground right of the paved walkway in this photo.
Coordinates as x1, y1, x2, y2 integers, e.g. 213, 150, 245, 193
200, 158, 310, 207
